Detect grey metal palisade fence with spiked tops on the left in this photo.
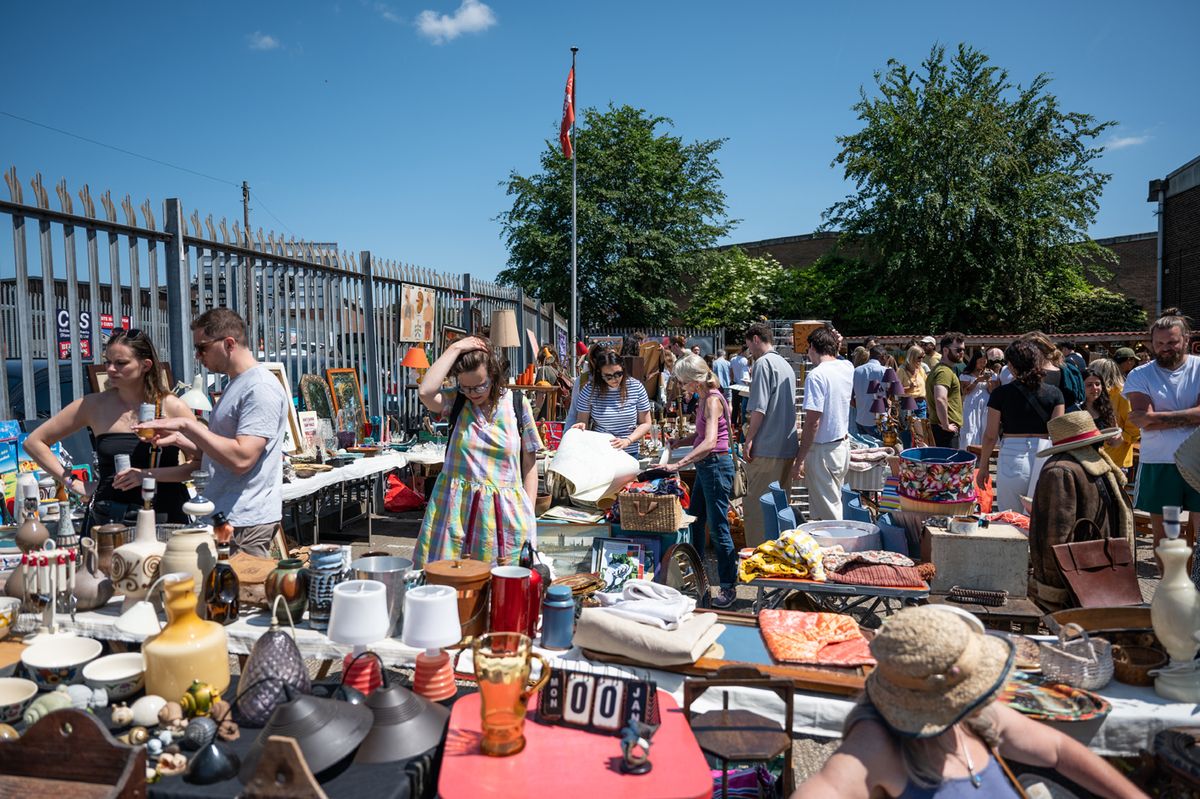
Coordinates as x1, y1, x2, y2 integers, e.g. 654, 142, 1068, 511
0, 169, 568, 423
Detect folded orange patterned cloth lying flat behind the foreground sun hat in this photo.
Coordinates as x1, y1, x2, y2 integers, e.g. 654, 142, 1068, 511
758, 611, 875, 666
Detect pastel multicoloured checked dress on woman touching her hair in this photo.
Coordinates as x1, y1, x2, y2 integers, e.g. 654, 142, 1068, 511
413, 391, 541, 569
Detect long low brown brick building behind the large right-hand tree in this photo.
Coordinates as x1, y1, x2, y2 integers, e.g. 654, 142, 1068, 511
730, 226, 1156, 318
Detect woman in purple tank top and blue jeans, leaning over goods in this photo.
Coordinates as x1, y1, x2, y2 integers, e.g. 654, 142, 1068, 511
667, 355, 738, 608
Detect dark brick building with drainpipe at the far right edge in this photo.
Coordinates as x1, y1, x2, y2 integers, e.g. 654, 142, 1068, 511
1147, 157, 1200, 319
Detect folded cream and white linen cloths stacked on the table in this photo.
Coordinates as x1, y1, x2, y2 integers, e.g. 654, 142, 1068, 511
575, 607, 725, 666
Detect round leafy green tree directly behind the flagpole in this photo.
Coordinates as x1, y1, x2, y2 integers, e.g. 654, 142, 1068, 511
499, 106, 733, 326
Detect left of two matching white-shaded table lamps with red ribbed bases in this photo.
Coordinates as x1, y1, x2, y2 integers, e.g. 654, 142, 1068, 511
325, 579, 390, 695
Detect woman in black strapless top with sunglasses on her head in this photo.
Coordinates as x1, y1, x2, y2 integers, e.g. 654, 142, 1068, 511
25, 329, 199, 534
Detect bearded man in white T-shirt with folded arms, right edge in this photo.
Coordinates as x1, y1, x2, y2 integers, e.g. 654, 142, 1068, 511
1124, 308, 1200, 566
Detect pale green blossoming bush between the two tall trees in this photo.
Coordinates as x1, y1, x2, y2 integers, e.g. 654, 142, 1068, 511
684, 247, 785, 331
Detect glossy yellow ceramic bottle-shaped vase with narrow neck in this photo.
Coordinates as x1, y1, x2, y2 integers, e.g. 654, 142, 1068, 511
142, 572, 229, 702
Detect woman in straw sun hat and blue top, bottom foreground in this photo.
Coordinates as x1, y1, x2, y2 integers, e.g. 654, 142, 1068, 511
792, 605, 1145, 799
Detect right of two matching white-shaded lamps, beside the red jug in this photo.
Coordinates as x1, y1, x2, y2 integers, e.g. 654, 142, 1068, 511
402, 585, 462, 702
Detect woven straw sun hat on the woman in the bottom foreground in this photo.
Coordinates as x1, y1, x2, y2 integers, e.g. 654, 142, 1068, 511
866, 605, 1014, 738
